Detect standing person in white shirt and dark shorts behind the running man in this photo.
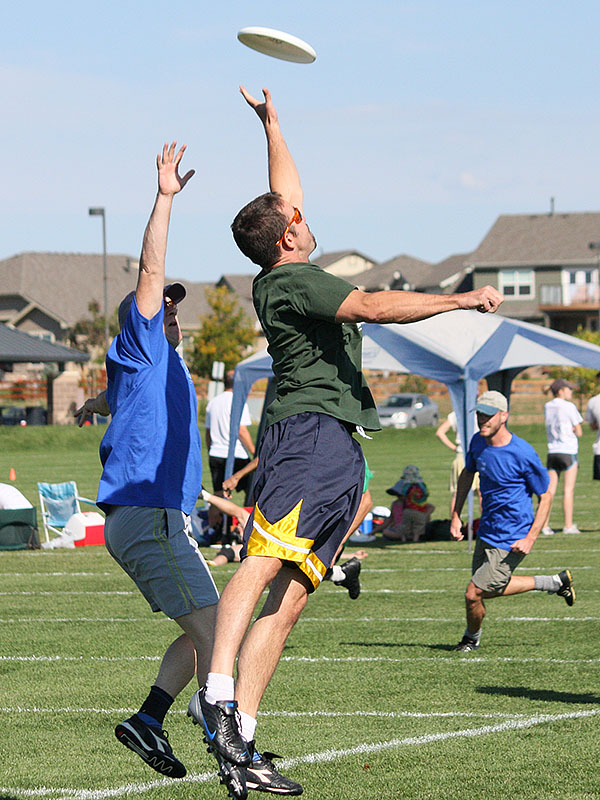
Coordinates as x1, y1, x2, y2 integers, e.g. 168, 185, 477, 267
542, 378, 583, 536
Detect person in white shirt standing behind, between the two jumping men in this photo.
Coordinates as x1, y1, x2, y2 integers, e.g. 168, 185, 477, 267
205, 370, 254, 495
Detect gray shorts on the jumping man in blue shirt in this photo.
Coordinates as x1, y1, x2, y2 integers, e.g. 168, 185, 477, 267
104, 506, 219, 619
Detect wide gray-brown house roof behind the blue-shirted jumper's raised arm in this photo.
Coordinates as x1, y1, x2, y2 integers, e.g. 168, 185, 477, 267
0, 253, 213, 329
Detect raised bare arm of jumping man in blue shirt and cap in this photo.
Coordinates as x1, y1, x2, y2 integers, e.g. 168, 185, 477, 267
135, 142, 194, 319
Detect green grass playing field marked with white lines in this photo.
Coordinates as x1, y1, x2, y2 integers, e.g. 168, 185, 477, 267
0, 426, 600, 800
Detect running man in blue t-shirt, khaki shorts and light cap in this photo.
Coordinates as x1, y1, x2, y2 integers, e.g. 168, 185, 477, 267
450, 391, 575, 653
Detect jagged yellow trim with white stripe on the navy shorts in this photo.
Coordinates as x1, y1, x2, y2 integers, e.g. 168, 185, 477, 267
247, 500, 314, 564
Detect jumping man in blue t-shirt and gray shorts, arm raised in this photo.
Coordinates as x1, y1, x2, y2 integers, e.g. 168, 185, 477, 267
76, 143, 218, 778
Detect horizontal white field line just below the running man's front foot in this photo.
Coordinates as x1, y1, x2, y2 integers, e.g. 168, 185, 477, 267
0, 655, 600, 664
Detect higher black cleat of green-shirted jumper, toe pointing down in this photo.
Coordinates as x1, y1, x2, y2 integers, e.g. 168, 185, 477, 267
188, 689, 251, 767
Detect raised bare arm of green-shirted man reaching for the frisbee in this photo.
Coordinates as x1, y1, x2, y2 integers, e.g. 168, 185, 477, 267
240, 86, 304, 211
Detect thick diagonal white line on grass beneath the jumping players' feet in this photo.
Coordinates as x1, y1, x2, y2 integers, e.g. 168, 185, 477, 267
0, 709, 600, 800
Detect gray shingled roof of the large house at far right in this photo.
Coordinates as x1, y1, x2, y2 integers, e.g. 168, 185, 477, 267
469, 212, 600, 267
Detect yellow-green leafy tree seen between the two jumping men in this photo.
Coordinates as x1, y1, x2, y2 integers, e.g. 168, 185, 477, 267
188, 286, 256, 377
